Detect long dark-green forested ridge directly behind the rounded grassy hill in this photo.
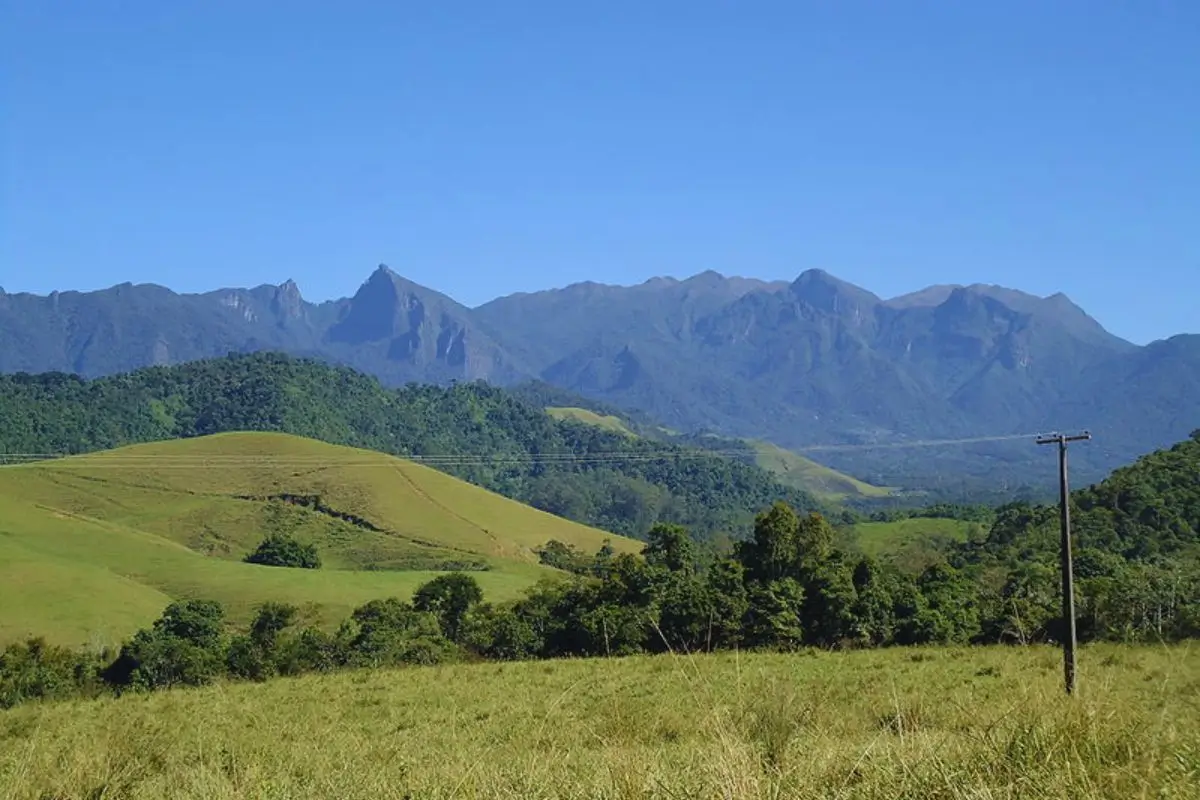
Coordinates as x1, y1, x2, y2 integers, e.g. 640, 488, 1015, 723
0, 354, 818, 536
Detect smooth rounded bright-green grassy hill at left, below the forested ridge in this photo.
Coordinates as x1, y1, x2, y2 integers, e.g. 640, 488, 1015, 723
0, 433, 641, 644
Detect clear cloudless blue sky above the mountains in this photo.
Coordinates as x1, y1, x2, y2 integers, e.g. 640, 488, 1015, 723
0, 0, 1200, 342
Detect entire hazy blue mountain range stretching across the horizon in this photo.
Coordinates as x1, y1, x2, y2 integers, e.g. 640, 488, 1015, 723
0, 265, 1200, 487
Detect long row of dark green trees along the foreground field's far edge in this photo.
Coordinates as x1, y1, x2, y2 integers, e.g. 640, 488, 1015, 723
7, 501, 1200, 706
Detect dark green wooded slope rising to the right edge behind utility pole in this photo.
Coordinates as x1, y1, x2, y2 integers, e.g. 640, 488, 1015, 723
952, 431, 1200, 638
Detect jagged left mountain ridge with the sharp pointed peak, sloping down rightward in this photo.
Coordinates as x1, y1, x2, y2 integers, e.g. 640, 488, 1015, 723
0, 266, 528, 385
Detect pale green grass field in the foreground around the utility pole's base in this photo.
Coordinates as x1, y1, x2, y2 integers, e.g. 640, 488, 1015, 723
0, 645, 1200, 800
